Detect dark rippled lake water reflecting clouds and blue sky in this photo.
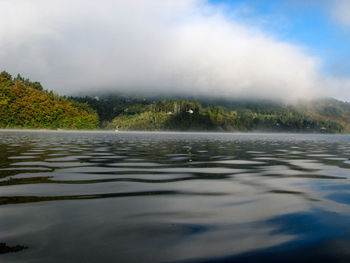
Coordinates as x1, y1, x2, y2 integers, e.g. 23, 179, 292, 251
0, 131, 350, 262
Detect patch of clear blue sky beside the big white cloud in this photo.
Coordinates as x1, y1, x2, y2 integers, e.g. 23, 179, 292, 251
209, 0, 350, 76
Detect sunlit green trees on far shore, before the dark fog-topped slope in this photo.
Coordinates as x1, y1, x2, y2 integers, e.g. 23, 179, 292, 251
95, 99, 350, 133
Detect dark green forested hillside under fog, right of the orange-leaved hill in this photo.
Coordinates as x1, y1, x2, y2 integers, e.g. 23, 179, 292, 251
72, 96, 350, 133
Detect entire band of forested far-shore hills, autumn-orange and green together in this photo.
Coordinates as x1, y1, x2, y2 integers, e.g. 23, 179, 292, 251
0, 72, 350, 133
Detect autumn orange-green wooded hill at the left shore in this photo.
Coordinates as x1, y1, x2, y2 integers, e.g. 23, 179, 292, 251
0, 71, 99, 129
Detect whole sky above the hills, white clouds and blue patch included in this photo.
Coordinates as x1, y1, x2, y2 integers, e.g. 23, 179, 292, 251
0, 0, 350, 101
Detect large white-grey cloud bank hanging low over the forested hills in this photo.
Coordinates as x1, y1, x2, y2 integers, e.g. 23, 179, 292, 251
0, 0, 345, 99
